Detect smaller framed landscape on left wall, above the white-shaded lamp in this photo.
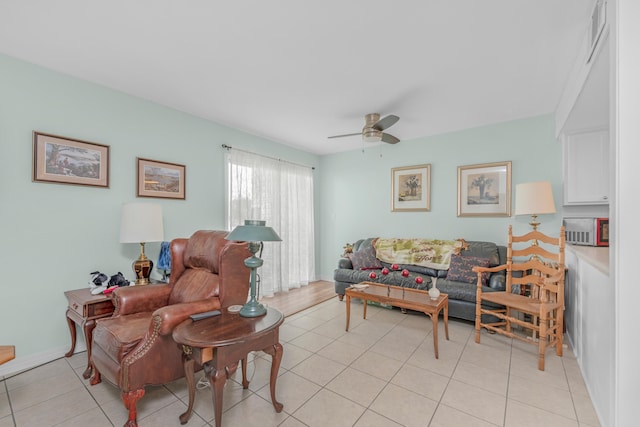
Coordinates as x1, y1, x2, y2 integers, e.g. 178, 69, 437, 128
138, 158, 186, 200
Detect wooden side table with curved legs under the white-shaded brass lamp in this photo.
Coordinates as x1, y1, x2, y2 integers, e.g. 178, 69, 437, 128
64, 288, 114, 379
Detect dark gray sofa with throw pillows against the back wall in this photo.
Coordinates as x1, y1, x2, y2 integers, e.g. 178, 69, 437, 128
333, 238, 507, 321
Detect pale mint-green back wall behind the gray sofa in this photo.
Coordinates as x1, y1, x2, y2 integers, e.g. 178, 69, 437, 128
320, 115, 562, 278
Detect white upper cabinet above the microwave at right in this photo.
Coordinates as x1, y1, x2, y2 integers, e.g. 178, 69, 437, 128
562, 129, 609, 205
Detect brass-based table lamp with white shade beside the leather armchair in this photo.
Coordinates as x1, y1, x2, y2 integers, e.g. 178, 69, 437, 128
120, 203, 164, 285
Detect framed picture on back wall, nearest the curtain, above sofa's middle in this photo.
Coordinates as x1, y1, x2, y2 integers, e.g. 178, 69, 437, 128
391, 165, 431, 212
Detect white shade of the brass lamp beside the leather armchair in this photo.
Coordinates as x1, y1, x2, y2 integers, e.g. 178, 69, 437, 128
120, 203, 164, 243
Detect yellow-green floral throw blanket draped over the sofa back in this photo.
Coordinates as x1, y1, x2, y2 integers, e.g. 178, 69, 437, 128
374, 239, 468, 270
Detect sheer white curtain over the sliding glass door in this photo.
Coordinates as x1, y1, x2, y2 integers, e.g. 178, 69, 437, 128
225, 149, 315, 296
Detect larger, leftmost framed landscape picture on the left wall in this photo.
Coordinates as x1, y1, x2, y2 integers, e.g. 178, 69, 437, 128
33, 132, 109, 188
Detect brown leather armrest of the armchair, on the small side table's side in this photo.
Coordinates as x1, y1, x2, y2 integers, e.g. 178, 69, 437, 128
113, 285, 171, 316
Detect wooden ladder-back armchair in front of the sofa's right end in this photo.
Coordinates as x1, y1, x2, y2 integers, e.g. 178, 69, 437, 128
473, 226, 565, 371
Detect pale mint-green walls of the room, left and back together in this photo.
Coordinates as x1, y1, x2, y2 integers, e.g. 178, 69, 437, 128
0, 55, 561, 376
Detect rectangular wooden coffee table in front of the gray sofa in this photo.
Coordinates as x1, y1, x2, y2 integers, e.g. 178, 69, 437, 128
345, 282, 449, 359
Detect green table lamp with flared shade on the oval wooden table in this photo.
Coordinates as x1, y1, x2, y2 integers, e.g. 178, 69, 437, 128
226, 219, 282, 317
